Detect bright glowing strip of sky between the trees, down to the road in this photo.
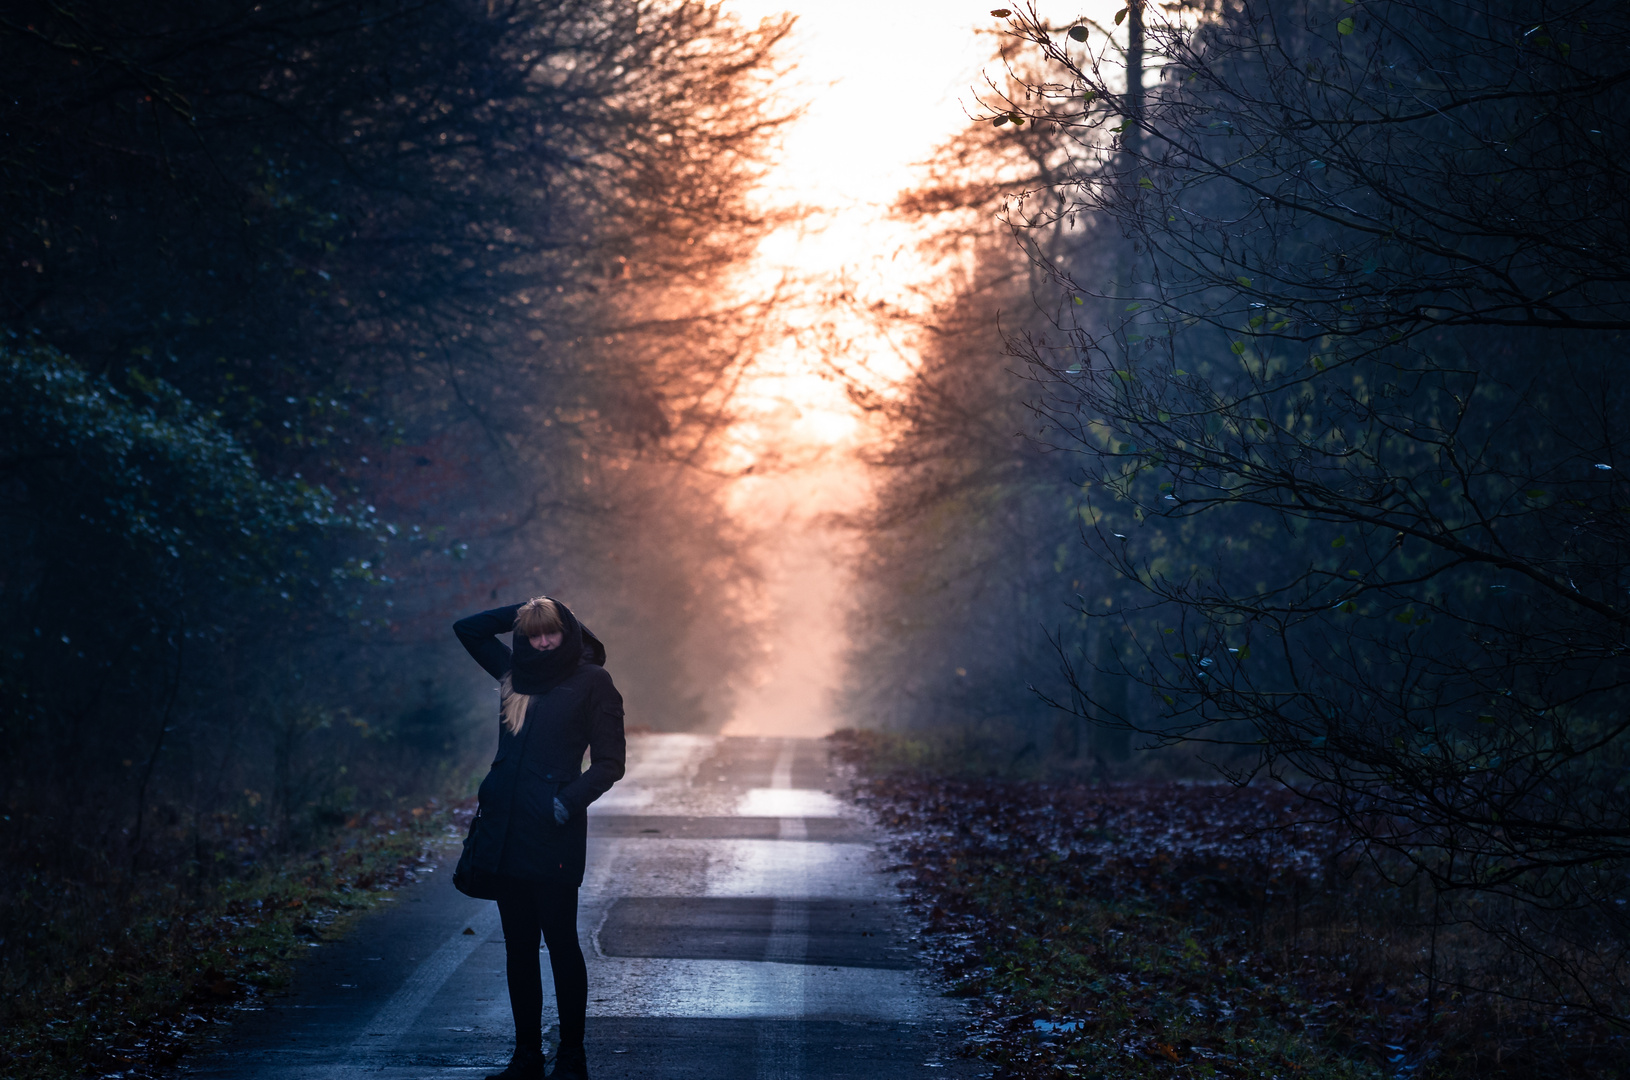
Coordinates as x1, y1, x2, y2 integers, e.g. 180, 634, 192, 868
724, 0, 1120, 736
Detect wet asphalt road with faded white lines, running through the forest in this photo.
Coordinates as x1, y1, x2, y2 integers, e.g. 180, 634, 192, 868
186, 735, 985, 1080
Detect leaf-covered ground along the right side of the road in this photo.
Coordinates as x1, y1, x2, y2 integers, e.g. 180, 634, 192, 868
835, 731, 1623, 1080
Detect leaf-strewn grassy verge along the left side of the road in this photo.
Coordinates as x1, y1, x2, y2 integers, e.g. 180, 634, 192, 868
0, 805, 468, 1080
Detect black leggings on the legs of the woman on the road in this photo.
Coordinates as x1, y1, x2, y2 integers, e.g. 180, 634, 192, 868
499, 878, 588, 1049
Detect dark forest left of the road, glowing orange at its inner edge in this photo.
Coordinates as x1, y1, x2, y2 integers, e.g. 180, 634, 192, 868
0, 0, 786, 1062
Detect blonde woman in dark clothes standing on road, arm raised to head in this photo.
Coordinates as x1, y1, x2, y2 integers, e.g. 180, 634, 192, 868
453, 596, 624, 1080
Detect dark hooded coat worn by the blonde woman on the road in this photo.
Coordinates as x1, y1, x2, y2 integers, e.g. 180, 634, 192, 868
453, 601, 626, 885
